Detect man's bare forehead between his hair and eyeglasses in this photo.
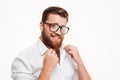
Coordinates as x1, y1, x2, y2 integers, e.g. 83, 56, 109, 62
46, 14, 67, 25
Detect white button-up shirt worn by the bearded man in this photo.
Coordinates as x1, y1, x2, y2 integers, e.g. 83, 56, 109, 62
12, 40, 78, 80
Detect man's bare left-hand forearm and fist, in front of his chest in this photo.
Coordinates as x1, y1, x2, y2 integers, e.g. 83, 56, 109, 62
38, 49, 58, 80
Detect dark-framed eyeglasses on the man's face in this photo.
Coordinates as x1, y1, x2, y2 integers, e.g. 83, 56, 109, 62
45, 22, 70, 34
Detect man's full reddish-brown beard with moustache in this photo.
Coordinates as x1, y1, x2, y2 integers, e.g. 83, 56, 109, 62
41, 30, 63, 49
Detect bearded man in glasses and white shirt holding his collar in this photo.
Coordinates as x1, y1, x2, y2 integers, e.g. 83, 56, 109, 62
12, 6, 91, 80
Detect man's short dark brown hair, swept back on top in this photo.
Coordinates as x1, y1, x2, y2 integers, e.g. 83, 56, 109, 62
42, 6, 68, 23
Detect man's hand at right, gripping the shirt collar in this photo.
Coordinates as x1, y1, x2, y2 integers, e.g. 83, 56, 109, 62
64, 44, 80, 63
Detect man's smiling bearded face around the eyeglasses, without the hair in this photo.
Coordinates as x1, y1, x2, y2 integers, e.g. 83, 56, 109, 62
41, 14, 67, 49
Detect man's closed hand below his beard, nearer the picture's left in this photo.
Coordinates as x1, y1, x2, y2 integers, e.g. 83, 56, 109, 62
43, 49, 58, 72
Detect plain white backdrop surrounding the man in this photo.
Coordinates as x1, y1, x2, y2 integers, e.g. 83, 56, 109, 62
0, 0, 120, 80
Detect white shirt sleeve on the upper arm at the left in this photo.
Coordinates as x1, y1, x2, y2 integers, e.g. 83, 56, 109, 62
11, 58, 35, 80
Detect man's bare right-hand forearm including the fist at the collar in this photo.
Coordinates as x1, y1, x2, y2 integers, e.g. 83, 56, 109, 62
64, 45, 91, 80
